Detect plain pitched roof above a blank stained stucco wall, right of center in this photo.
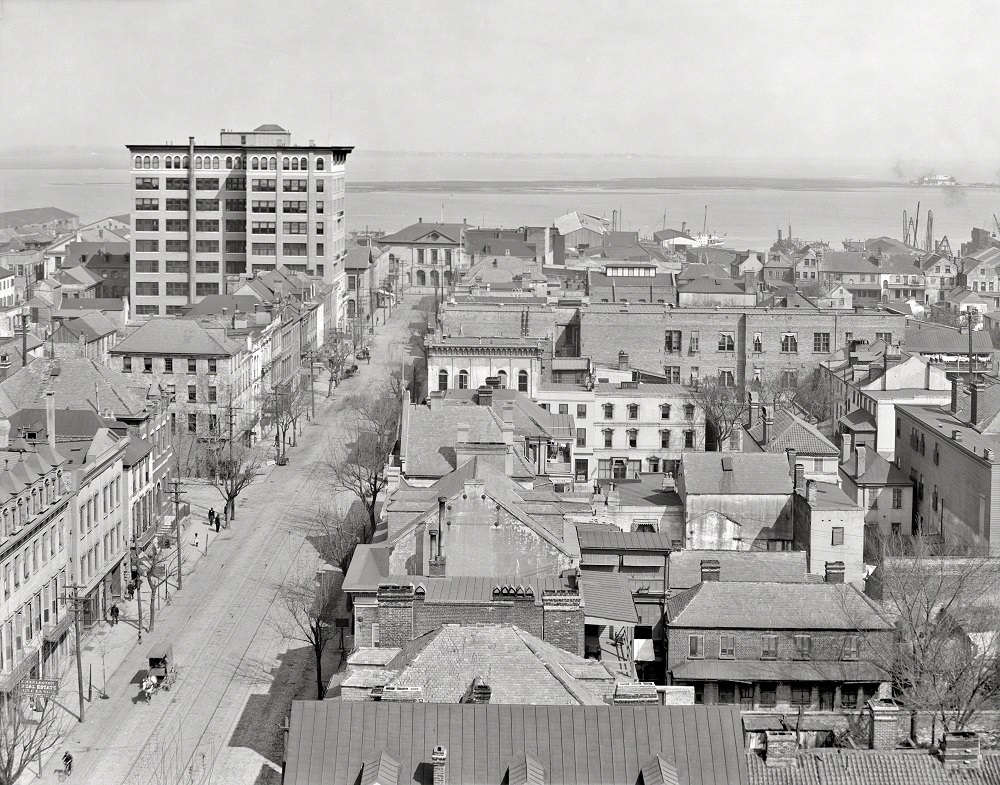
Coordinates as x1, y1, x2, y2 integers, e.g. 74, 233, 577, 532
681, 452, 792, 495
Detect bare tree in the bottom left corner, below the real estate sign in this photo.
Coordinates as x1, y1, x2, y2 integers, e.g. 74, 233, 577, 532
0, 686, 66, 785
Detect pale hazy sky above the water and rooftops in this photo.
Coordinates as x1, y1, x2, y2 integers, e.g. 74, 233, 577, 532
0, 0, 1000, 179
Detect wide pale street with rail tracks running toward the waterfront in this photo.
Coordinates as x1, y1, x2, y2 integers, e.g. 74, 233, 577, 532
25, 297, 426, 785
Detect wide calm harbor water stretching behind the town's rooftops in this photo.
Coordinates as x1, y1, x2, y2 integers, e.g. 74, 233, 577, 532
0, 154, 1000, 251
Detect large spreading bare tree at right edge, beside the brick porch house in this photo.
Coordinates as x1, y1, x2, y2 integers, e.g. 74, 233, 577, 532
866, 538, 1000, 735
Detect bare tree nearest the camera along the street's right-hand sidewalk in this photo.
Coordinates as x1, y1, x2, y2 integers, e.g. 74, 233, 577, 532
279, 569, 343, 700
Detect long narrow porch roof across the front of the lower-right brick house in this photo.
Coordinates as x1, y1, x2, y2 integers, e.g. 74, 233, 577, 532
671, 660, 889, 684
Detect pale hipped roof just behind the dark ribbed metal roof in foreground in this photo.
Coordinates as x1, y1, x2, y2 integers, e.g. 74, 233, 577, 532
352, 624, 626, 706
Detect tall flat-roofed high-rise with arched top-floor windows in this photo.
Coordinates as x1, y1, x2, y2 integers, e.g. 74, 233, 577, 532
128, 125, 354, 318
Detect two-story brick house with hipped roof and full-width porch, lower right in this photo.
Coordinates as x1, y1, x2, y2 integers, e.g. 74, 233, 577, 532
666, 560, 894, 713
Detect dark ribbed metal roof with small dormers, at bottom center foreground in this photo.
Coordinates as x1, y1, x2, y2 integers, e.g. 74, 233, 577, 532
283, 701, 749, 785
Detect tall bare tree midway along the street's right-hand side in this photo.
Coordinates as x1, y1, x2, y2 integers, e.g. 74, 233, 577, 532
326, 388, 400, 529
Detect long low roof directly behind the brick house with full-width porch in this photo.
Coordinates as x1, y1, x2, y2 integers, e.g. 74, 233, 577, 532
670, 550, 808, 589
